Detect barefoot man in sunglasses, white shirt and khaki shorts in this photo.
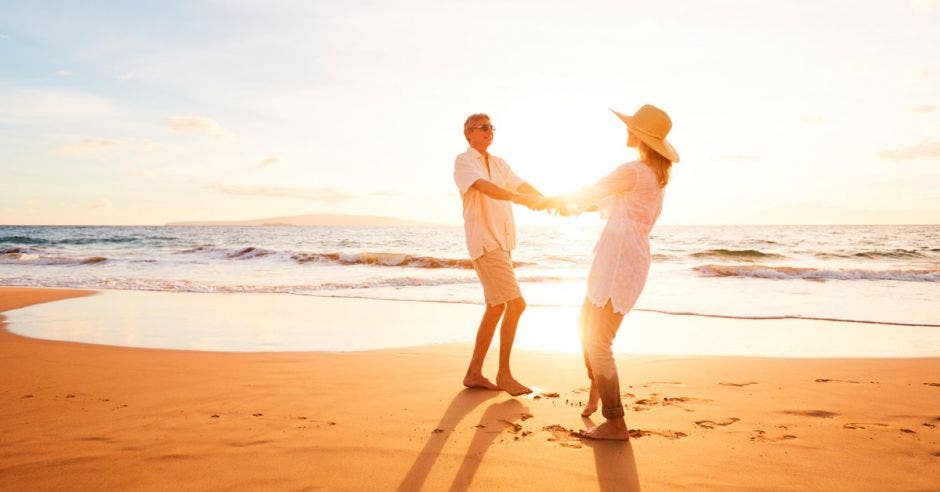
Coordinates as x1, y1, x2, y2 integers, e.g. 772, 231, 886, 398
454, 113, 542, 396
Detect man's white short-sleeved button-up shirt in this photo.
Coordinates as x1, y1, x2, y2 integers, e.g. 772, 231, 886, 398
454, 147, 525, 260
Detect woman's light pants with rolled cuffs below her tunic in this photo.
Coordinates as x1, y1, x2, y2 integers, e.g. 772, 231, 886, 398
579, 299, 623, 419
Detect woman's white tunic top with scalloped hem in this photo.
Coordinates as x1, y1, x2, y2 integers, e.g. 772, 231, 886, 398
571, 161, 665, 314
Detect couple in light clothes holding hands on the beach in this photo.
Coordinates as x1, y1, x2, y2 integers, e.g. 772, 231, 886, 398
454, 105, 679, 440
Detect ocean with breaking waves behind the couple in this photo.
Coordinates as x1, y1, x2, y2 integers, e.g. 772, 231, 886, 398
0, 226, 940, 328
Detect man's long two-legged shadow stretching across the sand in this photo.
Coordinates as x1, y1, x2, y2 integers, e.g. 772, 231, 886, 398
398, 389, 528, 491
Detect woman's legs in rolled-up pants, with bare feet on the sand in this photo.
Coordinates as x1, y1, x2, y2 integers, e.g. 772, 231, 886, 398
584, 301, 629, 440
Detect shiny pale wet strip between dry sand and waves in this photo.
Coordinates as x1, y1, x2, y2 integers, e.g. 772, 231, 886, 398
0, 289, 940, 359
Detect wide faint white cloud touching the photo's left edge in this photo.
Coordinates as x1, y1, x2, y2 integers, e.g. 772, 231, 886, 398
0, 89, 117, 125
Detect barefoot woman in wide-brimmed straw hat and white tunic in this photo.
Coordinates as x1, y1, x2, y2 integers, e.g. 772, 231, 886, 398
543, 105, 679, 441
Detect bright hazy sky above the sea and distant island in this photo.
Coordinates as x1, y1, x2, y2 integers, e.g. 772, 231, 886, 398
0, 0, 940, 225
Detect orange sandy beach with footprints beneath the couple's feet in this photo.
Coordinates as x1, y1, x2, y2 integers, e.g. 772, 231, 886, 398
0, 288, 940, 490
